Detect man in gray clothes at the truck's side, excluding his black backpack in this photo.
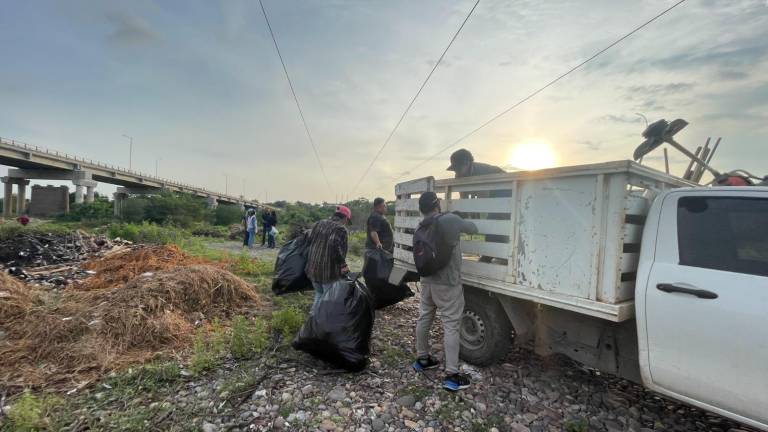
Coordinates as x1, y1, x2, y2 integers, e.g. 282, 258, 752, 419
413, 192, 477, 391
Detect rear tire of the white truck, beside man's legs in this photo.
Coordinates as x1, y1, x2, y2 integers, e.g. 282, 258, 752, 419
460, 287, 513, 366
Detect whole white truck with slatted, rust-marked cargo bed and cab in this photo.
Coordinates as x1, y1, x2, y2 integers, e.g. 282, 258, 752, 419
390, 161, 768, 430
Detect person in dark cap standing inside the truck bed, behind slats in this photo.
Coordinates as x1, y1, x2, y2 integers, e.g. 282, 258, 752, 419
448, 149, 512, 264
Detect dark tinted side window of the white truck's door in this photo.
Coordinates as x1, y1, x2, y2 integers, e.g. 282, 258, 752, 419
677, 196, 768, 276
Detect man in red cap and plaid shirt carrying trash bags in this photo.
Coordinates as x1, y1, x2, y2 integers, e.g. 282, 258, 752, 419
304, 205, 352, 308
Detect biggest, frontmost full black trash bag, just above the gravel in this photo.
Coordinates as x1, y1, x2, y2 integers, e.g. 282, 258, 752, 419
293, 277, 374, 372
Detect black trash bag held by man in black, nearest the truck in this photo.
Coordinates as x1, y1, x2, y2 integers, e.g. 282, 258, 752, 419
363, 249, 413, 309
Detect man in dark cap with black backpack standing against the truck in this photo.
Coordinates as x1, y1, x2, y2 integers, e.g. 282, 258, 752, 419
413, 192, 477, 391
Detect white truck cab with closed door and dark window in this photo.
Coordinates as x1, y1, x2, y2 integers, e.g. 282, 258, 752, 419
635, 187, 768, 429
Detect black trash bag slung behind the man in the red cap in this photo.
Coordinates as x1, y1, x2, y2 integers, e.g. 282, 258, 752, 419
272, 233, 312, 295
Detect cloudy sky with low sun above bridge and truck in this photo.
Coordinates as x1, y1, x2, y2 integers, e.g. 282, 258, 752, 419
0, 0, 768, 202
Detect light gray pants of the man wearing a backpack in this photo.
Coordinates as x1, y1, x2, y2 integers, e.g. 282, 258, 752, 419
416, 282, 464, 375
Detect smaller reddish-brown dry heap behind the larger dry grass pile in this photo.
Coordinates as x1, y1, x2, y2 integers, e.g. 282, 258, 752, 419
75, 245, 212, 290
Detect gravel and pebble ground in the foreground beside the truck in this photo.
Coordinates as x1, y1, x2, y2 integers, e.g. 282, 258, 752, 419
60, 298, 748, 432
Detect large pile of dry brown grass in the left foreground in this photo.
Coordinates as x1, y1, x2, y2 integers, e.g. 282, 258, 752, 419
0, 265, 260, 390
